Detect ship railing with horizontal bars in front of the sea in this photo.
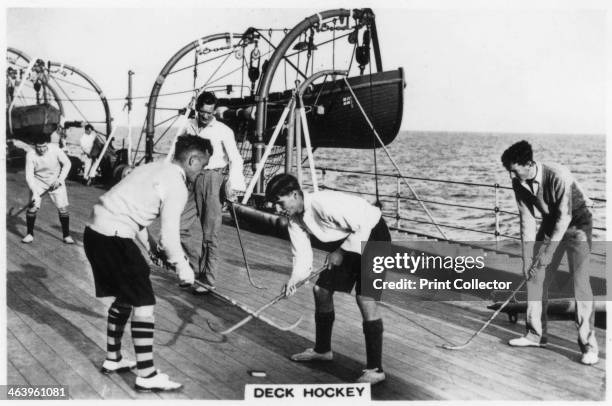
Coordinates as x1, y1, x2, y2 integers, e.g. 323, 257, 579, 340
294, 166, 606, 257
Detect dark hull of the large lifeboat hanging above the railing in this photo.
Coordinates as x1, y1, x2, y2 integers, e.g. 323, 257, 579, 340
219, 68, 405, 149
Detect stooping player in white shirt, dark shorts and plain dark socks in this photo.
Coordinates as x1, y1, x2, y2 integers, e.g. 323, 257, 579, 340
266, 174, 391, 384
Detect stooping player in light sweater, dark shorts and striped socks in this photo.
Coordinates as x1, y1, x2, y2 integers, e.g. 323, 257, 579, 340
83, 136, 212, 391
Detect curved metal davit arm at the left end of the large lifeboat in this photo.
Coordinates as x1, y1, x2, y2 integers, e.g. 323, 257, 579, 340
145, 32, 243, 162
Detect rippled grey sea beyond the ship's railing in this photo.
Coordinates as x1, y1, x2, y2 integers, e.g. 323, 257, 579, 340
63, 129, 606, 241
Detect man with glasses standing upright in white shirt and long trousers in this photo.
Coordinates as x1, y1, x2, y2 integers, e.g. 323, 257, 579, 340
175, 92, 246, 294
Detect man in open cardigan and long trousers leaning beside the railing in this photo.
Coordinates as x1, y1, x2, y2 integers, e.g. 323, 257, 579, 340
501, 141, 598, 365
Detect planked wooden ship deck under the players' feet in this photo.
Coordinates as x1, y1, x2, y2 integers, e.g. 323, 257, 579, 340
6, 167, 606, 400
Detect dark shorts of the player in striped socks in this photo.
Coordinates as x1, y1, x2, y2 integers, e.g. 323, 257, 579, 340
83, 227, 155, 306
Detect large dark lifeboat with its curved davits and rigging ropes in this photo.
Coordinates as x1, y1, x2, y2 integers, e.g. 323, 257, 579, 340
143, 9, 405, 191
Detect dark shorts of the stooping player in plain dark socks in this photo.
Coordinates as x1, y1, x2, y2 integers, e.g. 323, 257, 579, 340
316, 217, 391, 300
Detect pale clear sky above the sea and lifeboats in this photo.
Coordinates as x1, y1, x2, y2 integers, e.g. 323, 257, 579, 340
6, 1, 607, 134
